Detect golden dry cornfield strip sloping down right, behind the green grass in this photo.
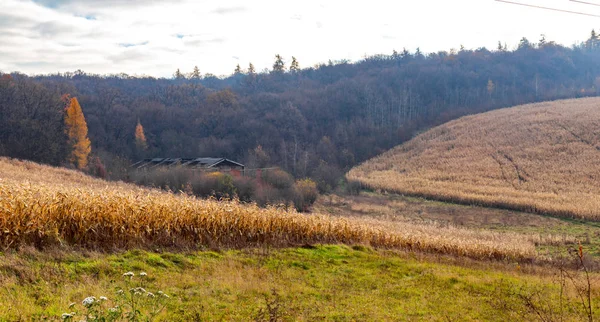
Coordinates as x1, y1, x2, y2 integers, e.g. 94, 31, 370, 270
0, 158, 536, 260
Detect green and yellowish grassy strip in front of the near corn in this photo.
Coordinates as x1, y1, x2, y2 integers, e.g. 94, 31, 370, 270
0, 246, 599, 321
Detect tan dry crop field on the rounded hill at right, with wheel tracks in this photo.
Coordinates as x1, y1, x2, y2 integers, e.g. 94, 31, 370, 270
347, 98, 600, 220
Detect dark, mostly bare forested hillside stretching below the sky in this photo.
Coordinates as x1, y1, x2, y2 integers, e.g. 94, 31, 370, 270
0, 33, 600, 189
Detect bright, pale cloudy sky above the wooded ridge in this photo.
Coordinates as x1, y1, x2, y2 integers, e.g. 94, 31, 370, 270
0, 0, 600, 77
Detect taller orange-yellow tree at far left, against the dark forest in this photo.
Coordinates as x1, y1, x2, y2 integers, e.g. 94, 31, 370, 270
65, 96, 92, 169
